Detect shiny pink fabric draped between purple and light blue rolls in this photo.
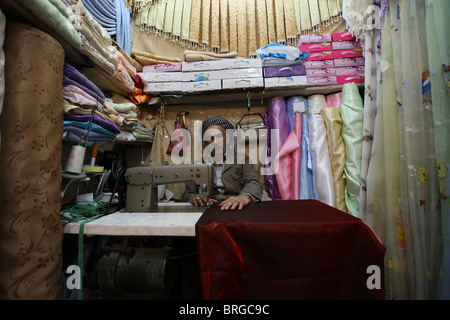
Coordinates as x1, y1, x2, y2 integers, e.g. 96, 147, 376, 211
276, 113, 302, 200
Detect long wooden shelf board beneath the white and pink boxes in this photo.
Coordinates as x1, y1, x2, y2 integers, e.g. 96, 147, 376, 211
159, 83, 364, 106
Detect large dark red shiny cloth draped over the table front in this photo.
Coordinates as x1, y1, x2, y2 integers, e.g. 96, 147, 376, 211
196, 200, 386, 300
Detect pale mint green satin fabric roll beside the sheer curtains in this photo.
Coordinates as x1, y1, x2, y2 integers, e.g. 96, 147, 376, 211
341, 83, 364, 217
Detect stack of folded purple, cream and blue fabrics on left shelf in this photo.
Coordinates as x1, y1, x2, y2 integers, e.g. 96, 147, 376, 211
62, 63, 120, 146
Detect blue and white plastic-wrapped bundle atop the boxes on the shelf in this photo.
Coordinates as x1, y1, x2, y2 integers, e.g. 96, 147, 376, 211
256, 43, 308, 67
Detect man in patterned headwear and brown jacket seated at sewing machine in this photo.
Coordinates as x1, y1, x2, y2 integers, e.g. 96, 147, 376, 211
186, 116, 263, 210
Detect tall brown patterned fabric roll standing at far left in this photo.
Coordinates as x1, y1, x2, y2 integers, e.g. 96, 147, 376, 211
0, 21, 64, 300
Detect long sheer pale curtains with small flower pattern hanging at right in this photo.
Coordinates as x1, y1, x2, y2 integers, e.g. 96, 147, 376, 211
360, 0, 449, 299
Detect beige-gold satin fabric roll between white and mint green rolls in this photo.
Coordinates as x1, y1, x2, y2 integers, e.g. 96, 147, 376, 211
321, 107, 347, 212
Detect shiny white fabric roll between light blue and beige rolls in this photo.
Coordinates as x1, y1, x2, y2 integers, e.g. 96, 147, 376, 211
308, 94, 334, 207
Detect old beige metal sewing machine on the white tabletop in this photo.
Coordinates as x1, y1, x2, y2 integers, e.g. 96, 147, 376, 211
125, 164, 213, 212
